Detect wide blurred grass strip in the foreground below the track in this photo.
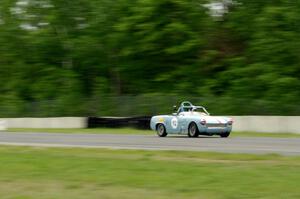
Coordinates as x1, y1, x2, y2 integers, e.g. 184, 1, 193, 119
0, 146, 300, 199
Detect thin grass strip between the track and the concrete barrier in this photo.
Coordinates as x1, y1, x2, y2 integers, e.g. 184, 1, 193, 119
8, 128, 300, 138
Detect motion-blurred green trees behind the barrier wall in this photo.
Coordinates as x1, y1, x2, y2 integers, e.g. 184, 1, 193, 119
0, 0, 300, 117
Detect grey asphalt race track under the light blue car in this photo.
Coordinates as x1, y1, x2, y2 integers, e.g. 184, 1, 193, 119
0, 132, 300, 155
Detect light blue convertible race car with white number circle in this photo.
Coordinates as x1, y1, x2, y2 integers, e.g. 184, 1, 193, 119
150, 101, 233, 138
